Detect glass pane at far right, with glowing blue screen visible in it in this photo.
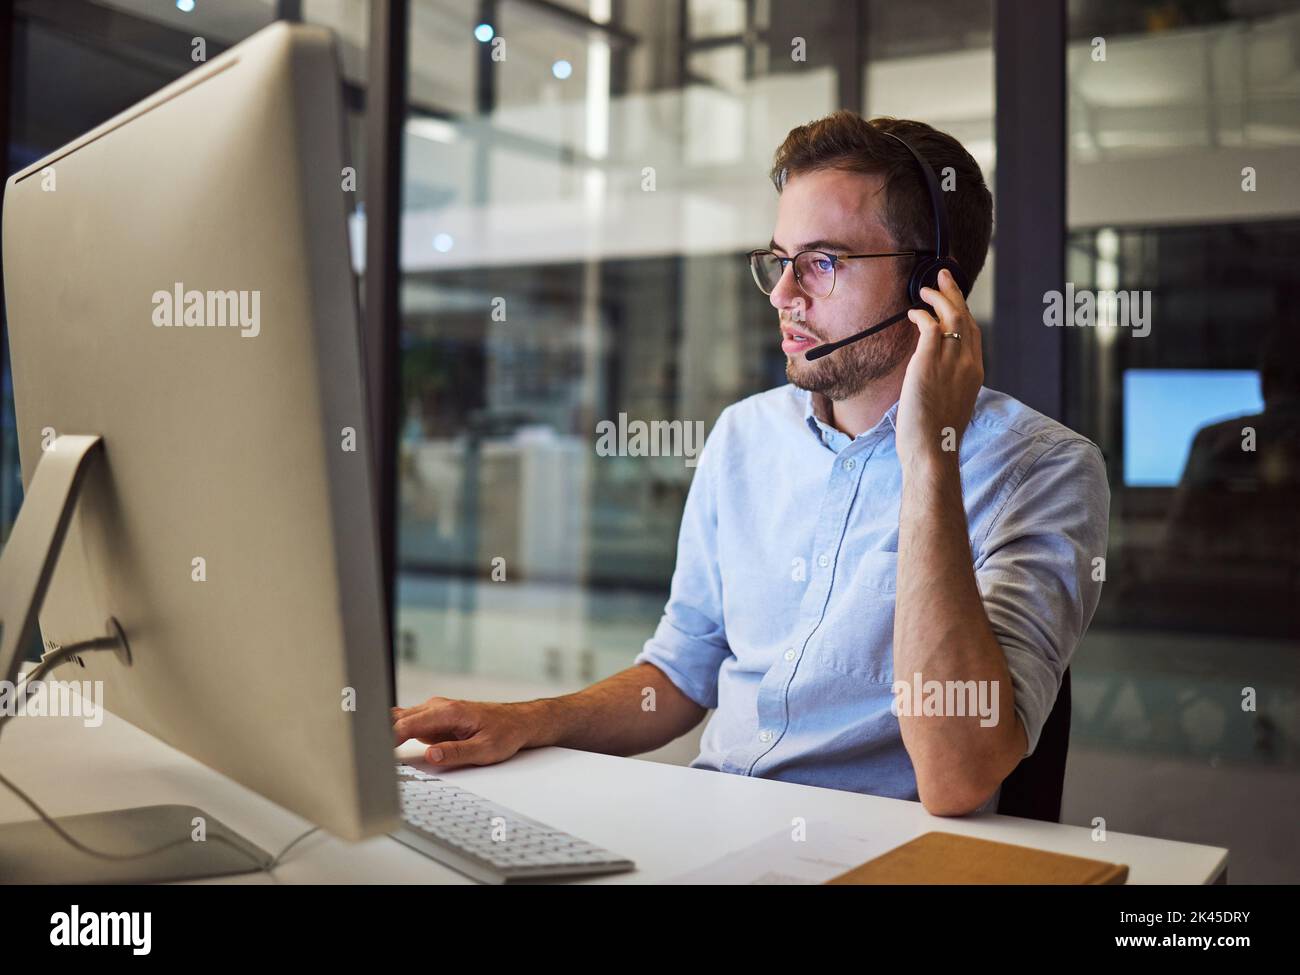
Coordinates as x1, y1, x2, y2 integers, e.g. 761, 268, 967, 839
1063, 3, 1300, 883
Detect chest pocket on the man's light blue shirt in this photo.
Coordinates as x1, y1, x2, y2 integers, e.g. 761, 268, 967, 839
809, 551, 898, 684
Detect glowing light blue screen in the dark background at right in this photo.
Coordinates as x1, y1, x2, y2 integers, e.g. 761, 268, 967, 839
1125, 369, 1264, 488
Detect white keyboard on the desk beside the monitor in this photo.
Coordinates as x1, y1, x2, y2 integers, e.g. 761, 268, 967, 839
390, 764, 636, 884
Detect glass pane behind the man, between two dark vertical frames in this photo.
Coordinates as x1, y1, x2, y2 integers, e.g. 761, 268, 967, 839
398, 0, 996, 696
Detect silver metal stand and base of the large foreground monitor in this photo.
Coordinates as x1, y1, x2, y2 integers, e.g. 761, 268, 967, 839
0, 434, 270, 884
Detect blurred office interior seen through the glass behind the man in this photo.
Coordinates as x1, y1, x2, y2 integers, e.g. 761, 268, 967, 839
0, 0, 1300, 883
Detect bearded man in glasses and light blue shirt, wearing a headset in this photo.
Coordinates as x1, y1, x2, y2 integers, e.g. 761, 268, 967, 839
393, 112, 1109, 815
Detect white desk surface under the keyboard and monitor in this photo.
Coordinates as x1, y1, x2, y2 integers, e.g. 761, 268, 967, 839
0, 681, 1227, 884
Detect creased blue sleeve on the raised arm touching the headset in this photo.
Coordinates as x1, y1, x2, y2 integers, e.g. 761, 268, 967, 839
975, 439, 1110, 758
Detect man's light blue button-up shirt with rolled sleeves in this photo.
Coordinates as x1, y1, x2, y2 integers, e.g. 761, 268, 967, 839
636, 385, 1110, 810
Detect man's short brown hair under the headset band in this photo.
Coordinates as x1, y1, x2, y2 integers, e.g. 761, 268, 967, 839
772, 111, 993, 292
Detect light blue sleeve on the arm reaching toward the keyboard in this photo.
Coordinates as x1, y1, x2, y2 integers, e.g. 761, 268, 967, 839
633, 410, 731, 709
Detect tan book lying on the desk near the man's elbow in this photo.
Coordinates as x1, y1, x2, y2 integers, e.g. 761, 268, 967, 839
826, 832, 1128, 884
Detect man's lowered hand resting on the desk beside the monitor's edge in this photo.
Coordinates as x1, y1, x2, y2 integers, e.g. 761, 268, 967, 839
393, 697, 536, 767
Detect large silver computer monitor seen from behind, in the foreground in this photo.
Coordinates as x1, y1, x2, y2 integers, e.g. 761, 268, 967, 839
0, 23, 398, 879
